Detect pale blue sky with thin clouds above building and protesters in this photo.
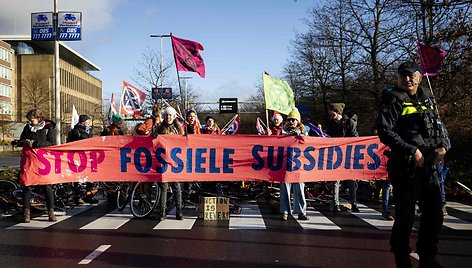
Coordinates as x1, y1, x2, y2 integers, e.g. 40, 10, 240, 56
0, 0, 320, 107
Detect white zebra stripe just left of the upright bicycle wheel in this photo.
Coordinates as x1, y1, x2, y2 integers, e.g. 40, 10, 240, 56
80, 207, 133, 230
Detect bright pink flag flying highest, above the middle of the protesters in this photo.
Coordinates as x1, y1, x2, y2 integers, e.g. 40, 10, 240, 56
171, 34, 205, 78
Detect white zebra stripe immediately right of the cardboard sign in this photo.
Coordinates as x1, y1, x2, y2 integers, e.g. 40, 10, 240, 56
229, 201, 267, 230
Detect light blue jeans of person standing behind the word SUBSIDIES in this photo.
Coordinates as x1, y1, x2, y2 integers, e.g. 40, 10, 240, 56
280, 182, 307, 215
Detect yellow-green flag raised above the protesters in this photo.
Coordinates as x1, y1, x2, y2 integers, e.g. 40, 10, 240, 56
262, 73, 295, 114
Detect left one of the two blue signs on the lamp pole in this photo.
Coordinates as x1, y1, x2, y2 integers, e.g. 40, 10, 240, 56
31, 12, 54, 41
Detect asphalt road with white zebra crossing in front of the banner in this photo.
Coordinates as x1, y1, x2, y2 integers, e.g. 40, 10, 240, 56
0, 196, 472, 268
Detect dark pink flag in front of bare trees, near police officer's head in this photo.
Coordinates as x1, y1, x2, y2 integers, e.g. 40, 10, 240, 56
416, 41, 446, 76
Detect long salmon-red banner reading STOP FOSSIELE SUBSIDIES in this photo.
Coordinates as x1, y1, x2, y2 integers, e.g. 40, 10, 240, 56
20, 135, 387, 185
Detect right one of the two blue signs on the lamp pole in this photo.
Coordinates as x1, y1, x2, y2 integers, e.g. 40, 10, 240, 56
57, 12, 82, 41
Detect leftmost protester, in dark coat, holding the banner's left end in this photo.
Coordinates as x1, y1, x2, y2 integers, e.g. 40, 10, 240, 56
20, 109, 57, 223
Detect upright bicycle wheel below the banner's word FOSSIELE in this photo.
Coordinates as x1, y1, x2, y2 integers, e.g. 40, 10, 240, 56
130, 182, 160, 218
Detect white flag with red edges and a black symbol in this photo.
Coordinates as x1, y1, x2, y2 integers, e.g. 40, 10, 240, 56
120, 81, 146, 118
